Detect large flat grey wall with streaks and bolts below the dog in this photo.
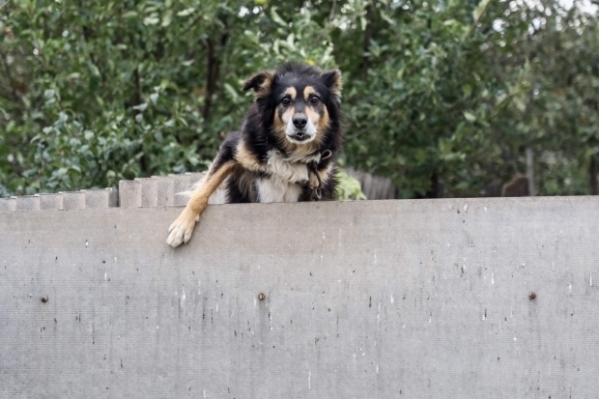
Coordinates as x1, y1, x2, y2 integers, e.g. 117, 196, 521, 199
0, 197, 599, 399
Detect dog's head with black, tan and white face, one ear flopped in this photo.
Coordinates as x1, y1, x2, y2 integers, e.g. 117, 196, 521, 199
243, 64, 341, 145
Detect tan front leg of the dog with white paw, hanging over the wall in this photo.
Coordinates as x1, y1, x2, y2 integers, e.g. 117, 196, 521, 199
166, 157, 236, 248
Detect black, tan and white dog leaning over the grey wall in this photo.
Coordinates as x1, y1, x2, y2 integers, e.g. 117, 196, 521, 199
166, 63, 343, 248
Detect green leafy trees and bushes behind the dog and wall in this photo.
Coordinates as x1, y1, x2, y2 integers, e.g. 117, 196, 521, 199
0, 0, 599, 198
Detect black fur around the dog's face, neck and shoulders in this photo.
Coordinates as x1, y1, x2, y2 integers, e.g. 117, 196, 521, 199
202, 64, 343, 203
